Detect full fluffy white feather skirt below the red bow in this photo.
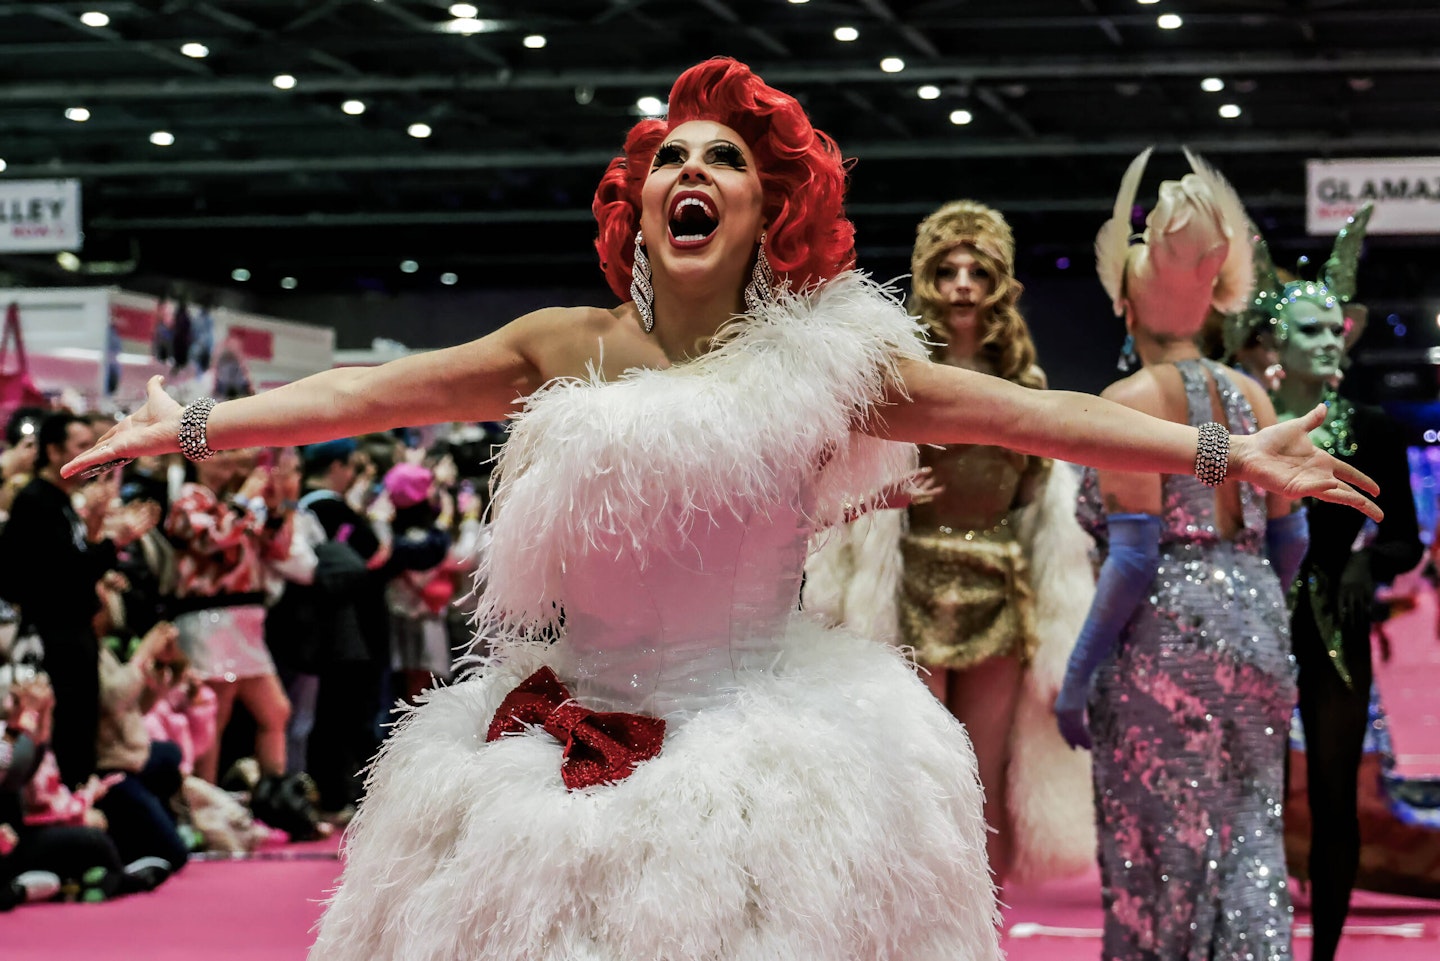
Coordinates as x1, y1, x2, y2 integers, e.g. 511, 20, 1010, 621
311, 617, 1001, 961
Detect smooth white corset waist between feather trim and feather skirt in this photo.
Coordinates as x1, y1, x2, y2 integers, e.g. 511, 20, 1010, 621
560, 506, 809, 718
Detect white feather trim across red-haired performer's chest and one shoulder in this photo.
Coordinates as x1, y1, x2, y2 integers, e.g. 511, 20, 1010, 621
477, 272, 924, 640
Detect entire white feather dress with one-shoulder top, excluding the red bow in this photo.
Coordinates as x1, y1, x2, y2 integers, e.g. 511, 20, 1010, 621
311, 274, 999, 961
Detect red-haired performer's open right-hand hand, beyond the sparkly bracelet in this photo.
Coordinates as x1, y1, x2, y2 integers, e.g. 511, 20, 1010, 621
1230, 403, 1385, 522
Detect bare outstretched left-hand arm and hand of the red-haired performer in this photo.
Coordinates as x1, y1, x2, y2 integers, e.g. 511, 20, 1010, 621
63, 308, 593, 477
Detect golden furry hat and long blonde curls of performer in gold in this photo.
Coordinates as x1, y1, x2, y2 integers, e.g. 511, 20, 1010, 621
910, 200, 1035, 380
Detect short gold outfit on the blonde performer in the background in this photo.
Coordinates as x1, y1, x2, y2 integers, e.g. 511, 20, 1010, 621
899, 444, 1048, 669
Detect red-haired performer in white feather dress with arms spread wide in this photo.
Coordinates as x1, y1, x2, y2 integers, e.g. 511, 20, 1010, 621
66, 61, 1372, 961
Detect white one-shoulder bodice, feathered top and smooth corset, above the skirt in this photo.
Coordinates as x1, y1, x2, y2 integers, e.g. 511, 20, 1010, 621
477, 274, 924, 718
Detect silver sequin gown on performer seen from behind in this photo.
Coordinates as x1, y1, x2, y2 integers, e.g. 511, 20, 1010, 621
1079, 360, 1296, 961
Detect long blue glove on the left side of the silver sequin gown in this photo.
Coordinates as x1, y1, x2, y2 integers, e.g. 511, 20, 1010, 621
1056, 514, 1161, 751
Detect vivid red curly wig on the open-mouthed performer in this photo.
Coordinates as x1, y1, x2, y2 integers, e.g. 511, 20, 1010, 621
590, 58, 855, 300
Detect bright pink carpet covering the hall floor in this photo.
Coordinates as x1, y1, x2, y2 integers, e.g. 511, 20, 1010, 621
8, 592, 1440, 961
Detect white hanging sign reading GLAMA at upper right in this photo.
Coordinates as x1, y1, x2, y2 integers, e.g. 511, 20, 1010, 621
1305, 157, 1440, 236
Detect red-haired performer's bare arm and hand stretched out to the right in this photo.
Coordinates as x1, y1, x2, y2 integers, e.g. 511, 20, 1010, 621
867, 360, 1382, 520
